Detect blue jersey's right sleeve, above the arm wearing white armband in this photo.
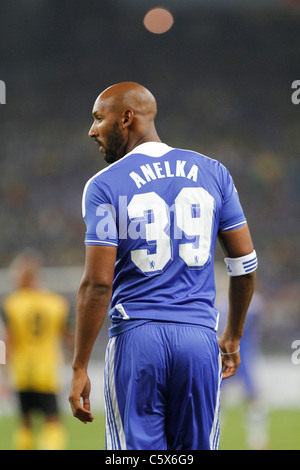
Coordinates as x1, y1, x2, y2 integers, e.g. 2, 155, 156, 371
219, 165, 247, 230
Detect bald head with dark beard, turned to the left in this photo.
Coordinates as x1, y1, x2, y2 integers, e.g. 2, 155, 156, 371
89, 82, 160, 163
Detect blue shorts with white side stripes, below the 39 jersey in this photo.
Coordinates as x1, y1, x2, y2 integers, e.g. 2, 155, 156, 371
104, 322, 222, 450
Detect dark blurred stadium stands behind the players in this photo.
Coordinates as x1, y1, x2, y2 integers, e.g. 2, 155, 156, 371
0, 0, 300, 448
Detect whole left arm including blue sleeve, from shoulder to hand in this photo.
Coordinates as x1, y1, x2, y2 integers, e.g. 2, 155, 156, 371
69, 175, 118, 423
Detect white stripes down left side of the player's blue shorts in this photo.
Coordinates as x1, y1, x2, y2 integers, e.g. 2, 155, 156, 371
104, 337, 126, 450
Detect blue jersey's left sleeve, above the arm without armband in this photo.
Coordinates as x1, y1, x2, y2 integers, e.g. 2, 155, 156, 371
82, 180, 118, 246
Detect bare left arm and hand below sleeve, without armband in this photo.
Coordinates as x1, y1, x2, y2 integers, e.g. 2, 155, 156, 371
69, 245, 117, 423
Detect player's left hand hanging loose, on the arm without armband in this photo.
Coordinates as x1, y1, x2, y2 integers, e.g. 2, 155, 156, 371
69, 370, 94, 424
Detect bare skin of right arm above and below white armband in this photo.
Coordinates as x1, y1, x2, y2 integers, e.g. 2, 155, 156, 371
219, 224, 256, 379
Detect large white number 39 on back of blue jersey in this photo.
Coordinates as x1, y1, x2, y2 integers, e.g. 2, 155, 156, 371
128, 188, 215, 275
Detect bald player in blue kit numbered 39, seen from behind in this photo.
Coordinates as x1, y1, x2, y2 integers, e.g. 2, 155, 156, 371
69, 82, 257, 450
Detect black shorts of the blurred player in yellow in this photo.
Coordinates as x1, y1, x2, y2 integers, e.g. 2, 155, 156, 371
19, 392, 58, 416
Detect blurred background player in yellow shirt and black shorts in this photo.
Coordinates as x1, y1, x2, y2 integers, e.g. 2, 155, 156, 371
2, 250, 70, 450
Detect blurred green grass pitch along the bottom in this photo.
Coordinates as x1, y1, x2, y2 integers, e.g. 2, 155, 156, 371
0, 407, 300, 450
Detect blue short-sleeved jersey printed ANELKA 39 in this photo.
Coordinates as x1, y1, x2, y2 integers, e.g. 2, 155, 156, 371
82, 142, 246, 336
